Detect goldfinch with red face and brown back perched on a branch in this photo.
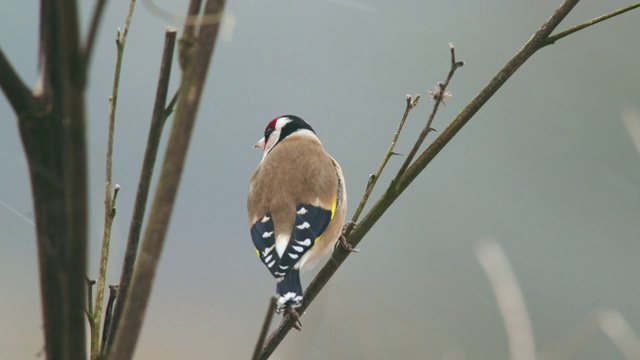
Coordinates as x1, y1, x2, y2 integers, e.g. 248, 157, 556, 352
247, 115, 356, 330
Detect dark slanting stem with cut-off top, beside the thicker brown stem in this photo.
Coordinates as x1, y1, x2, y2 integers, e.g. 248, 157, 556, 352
107, 29, 176, 351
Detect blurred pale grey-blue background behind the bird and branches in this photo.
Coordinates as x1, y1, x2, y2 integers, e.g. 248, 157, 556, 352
0, 0, 640, 360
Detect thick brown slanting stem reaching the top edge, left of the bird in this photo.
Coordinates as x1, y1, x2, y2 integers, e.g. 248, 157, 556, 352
109, 0, 224, 360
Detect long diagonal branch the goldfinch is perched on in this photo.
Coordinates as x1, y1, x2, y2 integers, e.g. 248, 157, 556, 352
259, 0, 579, 359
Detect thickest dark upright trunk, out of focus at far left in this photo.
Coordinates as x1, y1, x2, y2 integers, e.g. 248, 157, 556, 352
22, 0, 88, 359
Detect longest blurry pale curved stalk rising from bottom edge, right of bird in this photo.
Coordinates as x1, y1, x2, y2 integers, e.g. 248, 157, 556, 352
476, 241, 536, 360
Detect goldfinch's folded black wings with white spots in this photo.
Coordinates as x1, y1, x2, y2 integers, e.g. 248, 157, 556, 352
251, 204, 335, 278
